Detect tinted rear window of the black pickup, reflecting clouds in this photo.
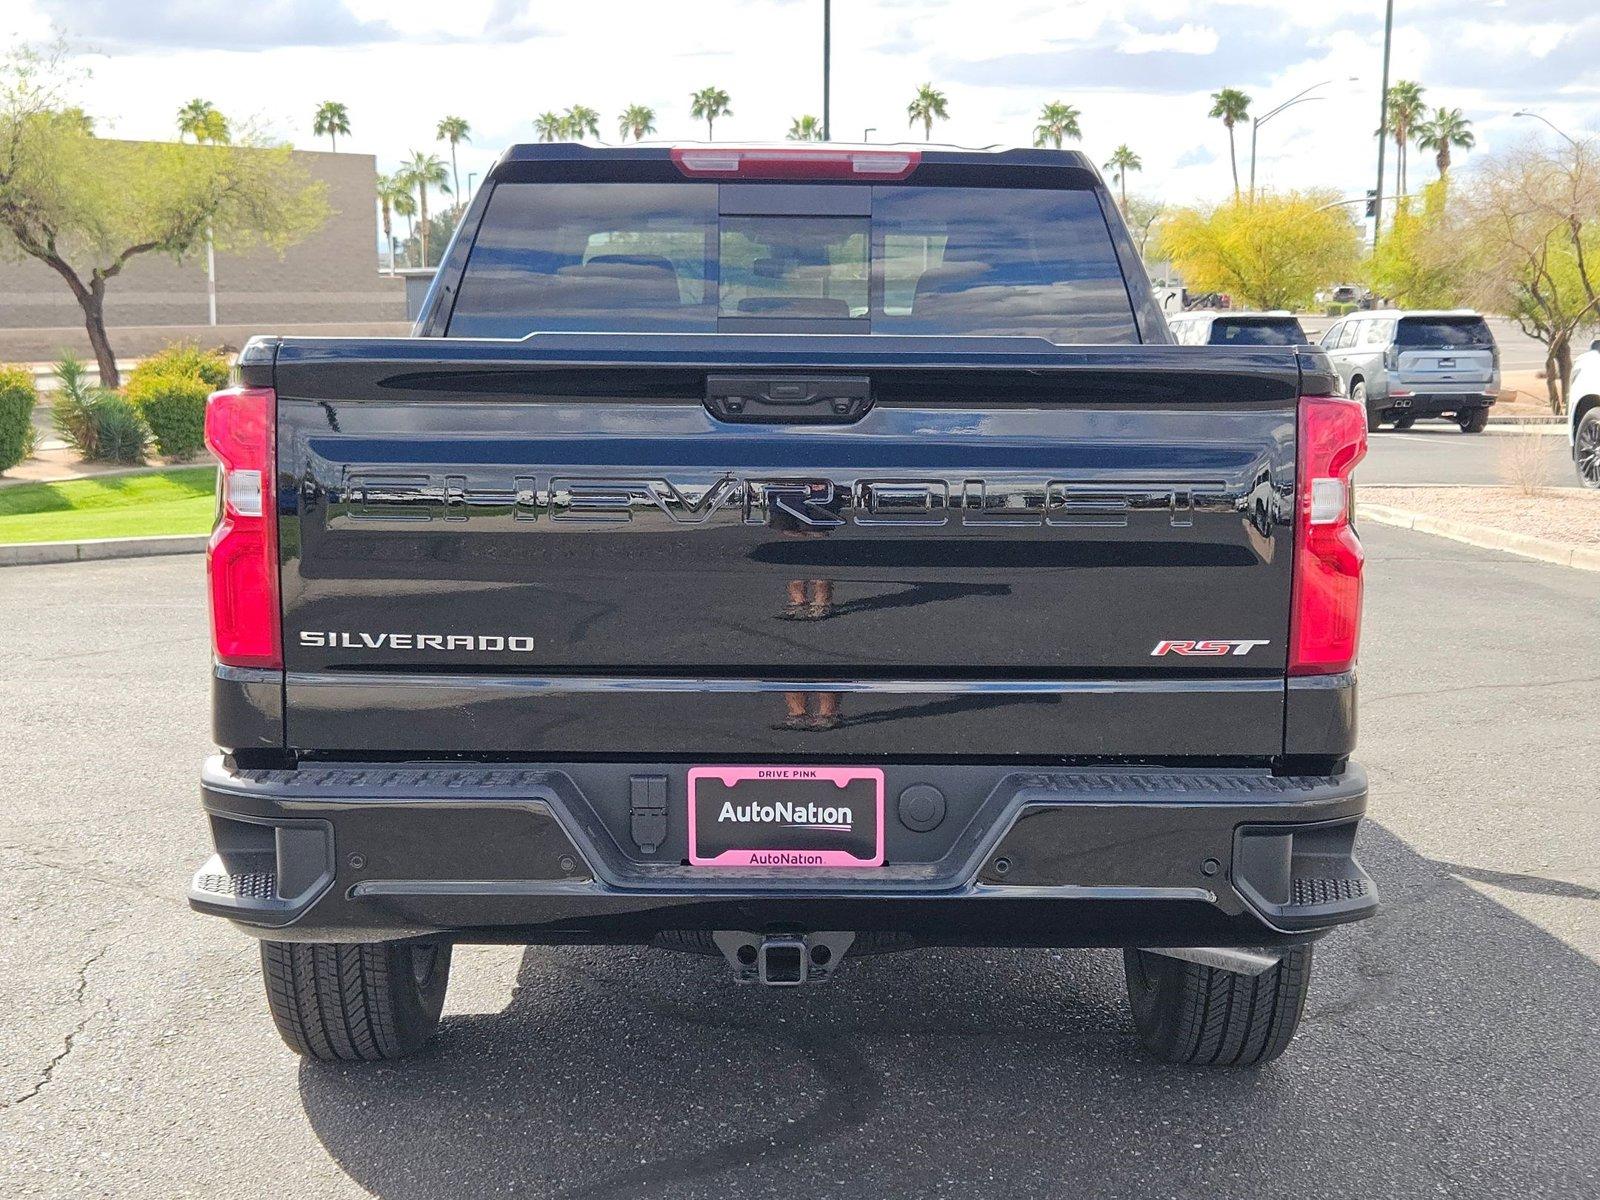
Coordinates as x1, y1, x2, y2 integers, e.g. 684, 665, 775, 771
450, 182, 1138, 342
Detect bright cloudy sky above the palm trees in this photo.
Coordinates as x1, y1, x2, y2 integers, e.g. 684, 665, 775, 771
0, 0, 1600, 202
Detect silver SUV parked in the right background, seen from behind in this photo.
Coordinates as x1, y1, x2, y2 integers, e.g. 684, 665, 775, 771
1322, 309, 1499, 434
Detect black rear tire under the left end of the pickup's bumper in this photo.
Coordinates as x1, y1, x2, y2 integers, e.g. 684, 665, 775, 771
261, 941, 450, 1062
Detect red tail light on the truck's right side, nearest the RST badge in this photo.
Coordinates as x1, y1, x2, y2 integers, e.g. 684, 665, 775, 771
1290, 395, 1366, 675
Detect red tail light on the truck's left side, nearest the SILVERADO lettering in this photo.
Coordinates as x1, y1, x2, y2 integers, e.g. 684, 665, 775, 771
205, 387, 283, 669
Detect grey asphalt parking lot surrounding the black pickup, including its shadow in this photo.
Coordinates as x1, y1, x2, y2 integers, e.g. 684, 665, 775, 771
0, 528, 1600, 1200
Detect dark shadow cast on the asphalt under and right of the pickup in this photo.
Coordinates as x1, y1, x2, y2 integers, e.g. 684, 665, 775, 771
301, 824, 1600, 1200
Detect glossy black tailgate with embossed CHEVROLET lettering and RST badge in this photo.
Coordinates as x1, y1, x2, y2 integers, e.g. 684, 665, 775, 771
274, 338, 1299, 757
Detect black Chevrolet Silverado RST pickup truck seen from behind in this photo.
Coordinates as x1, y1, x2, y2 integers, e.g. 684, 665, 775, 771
189, 146, 1376, 1066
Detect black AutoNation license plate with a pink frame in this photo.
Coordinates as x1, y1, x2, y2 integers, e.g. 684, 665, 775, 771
688, 766, 883, 869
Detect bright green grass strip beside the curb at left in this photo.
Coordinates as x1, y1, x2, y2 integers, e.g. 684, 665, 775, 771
0, 467, 216, 544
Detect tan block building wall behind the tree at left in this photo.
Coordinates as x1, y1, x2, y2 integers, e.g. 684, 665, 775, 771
0, 150, 405, 336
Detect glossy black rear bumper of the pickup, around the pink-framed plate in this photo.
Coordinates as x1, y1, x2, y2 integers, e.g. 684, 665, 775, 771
189, 758, 1378, 947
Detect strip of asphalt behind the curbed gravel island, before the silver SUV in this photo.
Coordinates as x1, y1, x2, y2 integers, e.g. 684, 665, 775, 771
1355, 421, 1581, 488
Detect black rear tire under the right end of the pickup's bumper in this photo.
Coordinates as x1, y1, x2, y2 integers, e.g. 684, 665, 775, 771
1122, 944, 1310, 1067
